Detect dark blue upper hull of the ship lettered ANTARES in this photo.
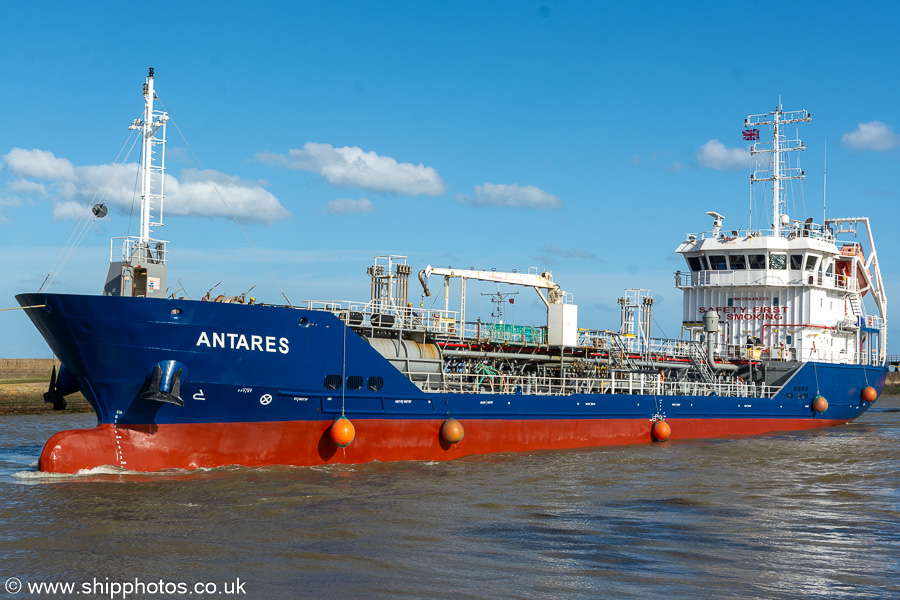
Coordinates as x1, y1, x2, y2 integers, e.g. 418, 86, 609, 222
17, 294, 887, 466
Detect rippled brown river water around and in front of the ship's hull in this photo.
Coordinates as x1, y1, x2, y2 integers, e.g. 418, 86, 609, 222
0, 397, 900, 600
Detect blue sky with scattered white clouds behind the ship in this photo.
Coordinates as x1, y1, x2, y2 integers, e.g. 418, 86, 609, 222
0, 1, 900, 357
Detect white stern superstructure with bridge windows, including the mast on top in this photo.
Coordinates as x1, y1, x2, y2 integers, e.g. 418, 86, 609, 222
675, 107, 887, 364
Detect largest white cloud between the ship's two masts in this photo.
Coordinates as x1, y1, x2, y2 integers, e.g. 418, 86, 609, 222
256, 142, 445, 196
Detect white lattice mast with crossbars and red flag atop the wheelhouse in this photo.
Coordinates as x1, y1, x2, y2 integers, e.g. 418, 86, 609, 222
744, 105, 812, 237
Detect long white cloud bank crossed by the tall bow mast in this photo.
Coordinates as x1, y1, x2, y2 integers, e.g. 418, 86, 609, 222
3, 148, 290, 222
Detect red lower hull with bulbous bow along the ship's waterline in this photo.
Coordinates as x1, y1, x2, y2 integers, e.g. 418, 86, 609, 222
39, 419, 846, 473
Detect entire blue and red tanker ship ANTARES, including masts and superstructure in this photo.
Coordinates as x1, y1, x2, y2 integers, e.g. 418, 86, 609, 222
17, 69, 887, 473
